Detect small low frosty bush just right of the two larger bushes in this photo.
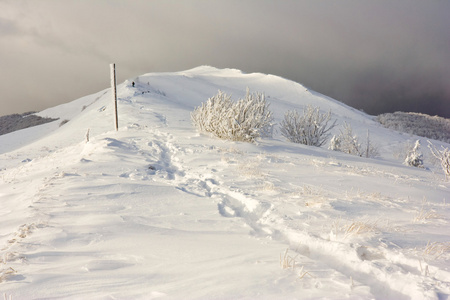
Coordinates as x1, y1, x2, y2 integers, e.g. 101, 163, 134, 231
329, 123, 378, 157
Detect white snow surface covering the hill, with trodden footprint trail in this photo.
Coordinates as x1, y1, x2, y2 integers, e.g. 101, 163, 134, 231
0, 66, 450, 300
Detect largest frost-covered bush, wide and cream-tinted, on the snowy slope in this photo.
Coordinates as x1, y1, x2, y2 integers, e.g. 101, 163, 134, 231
191, 89, 273, 142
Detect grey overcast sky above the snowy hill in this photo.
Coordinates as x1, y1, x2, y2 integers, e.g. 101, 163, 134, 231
0, 0, 450, 118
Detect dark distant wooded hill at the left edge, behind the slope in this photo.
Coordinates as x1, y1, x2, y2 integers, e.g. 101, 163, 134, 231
0, 112, 58, 135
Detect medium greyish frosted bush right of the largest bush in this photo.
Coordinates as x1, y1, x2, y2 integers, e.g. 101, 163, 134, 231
281, 105, 336, 147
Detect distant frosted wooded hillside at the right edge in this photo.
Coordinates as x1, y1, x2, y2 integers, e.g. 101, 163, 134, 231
377, 112, 450, 143
